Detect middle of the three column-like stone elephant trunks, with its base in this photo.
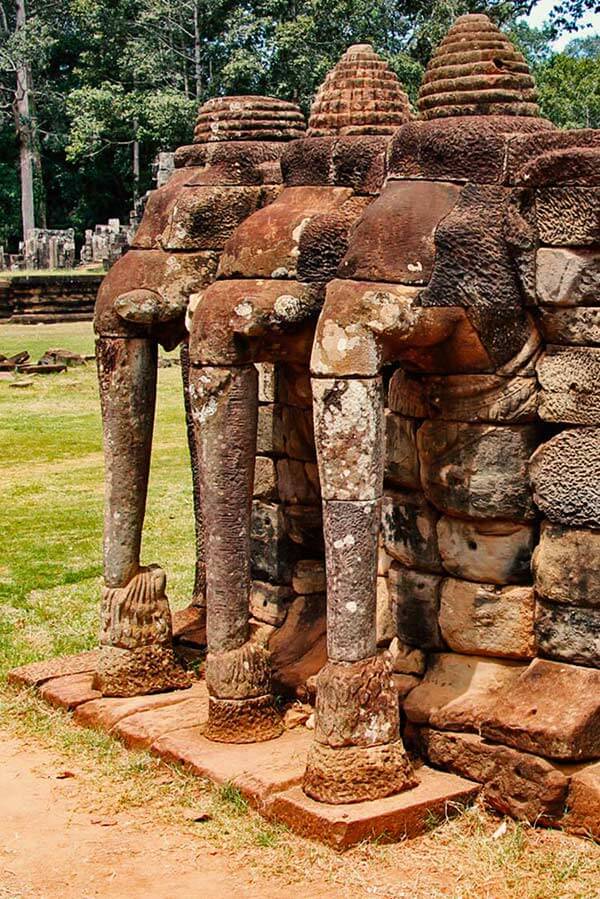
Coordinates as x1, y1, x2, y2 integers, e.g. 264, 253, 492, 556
190, 365, 282, 743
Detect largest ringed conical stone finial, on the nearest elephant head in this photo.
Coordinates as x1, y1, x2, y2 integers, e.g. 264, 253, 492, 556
418, 15, 539, 119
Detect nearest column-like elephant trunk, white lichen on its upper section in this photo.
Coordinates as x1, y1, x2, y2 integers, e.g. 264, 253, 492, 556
304, 377, 416, 803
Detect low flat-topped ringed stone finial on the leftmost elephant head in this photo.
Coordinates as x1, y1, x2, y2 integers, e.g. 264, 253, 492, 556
194, 96, 306, 144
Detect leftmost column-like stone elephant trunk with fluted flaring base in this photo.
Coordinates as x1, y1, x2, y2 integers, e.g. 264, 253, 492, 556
94, 337, 190, 696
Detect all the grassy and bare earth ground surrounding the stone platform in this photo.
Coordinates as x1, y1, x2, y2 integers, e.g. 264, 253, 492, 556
0, 322, 600, 899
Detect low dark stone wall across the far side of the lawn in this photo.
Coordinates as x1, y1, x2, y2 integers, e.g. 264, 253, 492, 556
0, 275, 102, 324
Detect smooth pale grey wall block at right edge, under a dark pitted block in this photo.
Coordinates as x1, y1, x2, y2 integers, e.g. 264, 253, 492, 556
535, 247, 600, 306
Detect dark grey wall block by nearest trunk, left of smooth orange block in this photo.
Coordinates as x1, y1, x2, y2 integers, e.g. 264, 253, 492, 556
388, 562, 443, 650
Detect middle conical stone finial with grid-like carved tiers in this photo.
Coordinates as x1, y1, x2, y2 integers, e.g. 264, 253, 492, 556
308, 44, 410, 137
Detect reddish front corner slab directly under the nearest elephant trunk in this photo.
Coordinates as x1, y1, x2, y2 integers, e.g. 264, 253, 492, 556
265, 766, 479, 849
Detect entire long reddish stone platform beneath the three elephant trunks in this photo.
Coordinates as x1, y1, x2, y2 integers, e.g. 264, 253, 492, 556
9, 652, 480, 849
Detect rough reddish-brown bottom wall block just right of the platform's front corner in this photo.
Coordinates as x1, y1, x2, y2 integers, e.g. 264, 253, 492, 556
420, 728, 568, 824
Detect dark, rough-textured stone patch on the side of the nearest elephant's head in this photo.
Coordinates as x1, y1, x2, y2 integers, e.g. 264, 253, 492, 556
421, 183, 530, 371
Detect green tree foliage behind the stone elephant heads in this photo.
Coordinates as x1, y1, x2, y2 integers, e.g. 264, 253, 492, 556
0, 0, 600, 251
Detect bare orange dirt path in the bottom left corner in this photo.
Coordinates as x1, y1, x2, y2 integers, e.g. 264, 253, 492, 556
0, 733, 339, 899
